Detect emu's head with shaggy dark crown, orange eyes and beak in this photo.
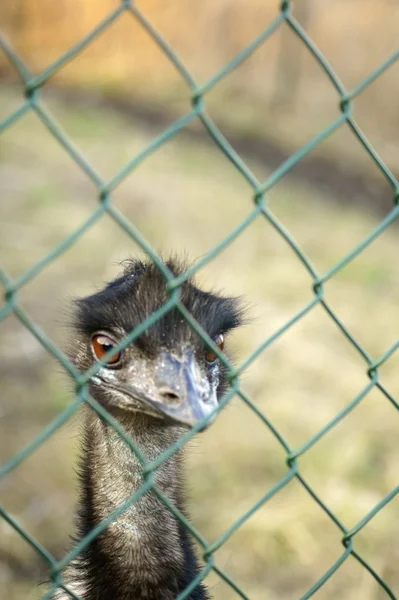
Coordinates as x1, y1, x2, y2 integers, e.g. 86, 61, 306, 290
70, 261, 241, 426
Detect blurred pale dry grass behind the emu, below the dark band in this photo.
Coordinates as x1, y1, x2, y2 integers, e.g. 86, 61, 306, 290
0, 85, 399, 600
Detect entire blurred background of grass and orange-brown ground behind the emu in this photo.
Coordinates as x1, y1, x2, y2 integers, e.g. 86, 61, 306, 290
0, 0, 399, 600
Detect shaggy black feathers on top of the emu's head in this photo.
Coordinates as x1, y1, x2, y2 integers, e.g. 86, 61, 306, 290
76, 261, 242, 354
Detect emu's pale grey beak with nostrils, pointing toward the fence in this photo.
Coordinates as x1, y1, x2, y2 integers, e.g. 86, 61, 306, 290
150, 351, 218, 429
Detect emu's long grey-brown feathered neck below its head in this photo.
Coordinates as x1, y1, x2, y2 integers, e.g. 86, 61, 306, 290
81, 412, 189, 600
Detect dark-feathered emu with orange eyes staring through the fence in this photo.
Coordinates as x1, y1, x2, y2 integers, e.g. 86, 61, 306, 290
53, 260, 242, 600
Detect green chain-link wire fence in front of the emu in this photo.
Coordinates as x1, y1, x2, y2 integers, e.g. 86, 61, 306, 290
0, 0, 399, 600
